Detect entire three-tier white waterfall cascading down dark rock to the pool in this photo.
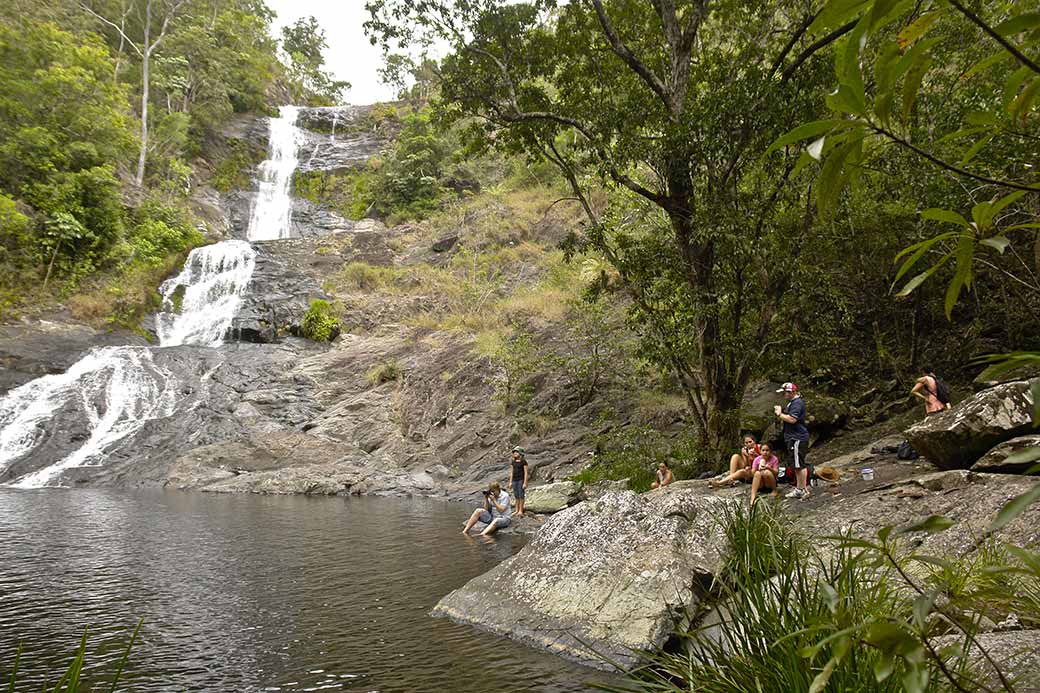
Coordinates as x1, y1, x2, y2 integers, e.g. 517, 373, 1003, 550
0, 106, 300, 488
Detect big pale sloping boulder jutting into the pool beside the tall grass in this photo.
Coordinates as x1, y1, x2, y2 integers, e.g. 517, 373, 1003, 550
434, 489, 734, 667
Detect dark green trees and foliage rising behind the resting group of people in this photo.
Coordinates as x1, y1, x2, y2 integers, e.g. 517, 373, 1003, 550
368, 0, 1040, 446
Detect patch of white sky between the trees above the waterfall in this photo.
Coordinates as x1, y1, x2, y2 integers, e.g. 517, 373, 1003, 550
266, 0, 394, 104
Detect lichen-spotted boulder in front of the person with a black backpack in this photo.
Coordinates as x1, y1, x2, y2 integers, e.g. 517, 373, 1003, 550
906, 380, 1033, 469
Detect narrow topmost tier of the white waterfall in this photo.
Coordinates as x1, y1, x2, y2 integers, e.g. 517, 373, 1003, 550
249, 106, 300, 240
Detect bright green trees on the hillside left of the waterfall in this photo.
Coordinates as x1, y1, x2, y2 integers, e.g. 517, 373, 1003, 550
0, 0, 341, 327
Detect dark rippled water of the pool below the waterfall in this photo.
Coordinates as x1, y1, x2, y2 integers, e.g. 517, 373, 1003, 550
0, 489, 602, 693
